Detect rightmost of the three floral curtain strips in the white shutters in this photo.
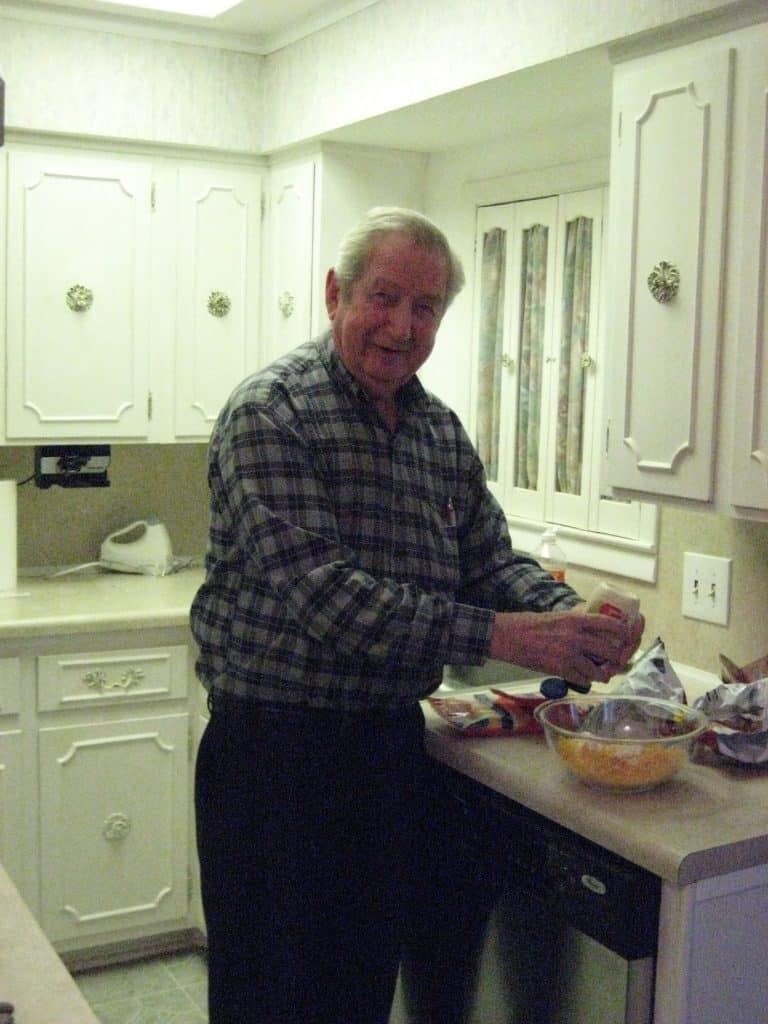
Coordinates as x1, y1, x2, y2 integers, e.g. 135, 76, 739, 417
555, 217, 592, 495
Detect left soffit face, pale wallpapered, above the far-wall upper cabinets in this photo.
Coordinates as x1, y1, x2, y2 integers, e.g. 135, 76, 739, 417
0, 13, 263, 153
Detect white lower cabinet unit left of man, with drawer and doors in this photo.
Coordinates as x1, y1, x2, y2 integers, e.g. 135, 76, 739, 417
0, 628, 202, 958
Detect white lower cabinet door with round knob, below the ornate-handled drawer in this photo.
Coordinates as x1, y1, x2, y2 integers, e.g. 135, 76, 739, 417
39, 714, 188, 946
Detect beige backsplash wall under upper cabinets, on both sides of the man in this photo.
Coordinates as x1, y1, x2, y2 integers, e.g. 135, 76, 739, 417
0, 444, 768, 672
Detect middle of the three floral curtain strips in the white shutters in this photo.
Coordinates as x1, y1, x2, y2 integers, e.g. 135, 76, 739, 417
515, 224, 549, 490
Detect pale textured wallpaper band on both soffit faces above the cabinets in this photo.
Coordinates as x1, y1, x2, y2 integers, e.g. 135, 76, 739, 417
0, 0, 734, 153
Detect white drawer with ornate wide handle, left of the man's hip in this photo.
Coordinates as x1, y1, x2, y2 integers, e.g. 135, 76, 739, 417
37, 644, 187, 711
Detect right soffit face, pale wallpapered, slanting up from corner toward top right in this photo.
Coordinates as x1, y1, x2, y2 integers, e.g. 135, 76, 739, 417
263, 0, 754, 152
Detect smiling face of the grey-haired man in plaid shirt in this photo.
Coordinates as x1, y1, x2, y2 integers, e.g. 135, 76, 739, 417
326, 231, 449, 400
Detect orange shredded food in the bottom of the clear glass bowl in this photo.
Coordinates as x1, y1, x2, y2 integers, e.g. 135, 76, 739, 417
555, 736, 687, 790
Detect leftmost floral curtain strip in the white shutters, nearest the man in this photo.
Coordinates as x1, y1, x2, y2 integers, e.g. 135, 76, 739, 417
477, 227, 507, 480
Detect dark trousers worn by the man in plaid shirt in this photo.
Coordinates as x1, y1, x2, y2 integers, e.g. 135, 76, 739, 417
196, 707, 424, 1024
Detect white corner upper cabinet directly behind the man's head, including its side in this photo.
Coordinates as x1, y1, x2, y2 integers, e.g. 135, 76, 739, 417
262, 143, 426, 362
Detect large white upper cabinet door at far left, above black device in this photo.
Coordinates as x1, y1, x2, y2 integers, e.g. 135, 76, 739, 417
6, 150, 152, 439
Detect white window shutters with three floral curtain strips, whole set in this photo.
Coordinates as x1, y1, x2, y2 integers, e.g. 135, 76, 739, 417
475, 188, 603, 527
